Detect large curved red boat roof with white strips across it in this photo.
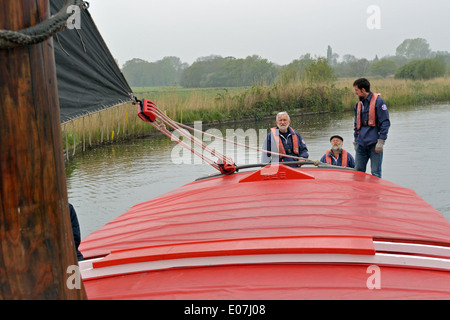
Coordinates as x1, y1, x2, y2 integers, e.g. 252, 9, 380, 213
80, 165, 450, 300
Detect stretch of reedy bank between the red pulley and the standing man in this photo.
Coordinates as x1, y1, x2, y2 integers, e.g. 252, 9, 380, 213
135, 82, 345, 123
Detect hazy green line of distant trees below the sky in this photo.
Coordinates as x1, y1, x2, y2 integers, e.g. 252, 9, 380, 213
122, 38, 450, 88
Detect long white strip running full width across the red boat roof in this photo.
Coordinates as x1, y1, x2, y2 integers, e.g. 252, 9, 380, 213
80, 253, 450, 280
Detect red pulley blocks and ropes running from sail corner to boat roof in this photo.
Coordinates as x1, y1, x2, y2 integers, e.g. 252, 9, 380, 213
135, 98, 318, 174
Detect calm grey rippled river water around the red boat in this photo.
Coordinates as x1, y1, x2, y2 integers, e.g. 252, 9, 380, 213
66, 104, 450, 238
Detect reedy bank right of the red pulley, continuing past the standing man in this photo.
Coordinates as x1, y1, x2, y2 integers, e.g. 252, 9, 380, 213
132, 77, 450, 123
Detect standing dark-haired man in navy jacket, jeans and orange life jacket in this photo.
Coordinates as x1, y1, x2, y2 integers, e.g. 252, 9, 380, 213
353, 78, 391, 178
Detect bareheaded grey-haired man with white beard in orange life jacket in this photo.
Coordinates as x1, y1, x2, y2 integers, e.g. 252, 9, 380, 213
261, 111, 309, 167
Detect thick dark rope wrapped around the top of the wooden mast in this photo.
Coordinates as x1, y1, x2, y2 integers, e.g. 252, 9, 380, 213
0, 0, 89, 49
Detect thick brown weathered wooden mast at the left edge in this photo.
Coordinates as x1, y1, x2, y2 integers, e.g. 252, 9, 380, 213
0, 0, 86, 299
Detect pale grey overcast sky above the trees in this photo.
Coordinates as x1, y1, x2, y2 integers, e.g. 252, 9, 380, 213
88, 0, 450, 66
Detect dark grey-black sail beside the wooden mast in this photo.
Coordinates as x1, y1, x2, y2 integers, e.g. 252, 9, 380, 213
50, 0, 132, 123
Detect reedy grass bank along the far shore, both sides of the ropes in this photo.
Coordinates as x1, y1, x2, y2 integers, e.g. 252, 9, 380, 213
61, 76, 450, 161
